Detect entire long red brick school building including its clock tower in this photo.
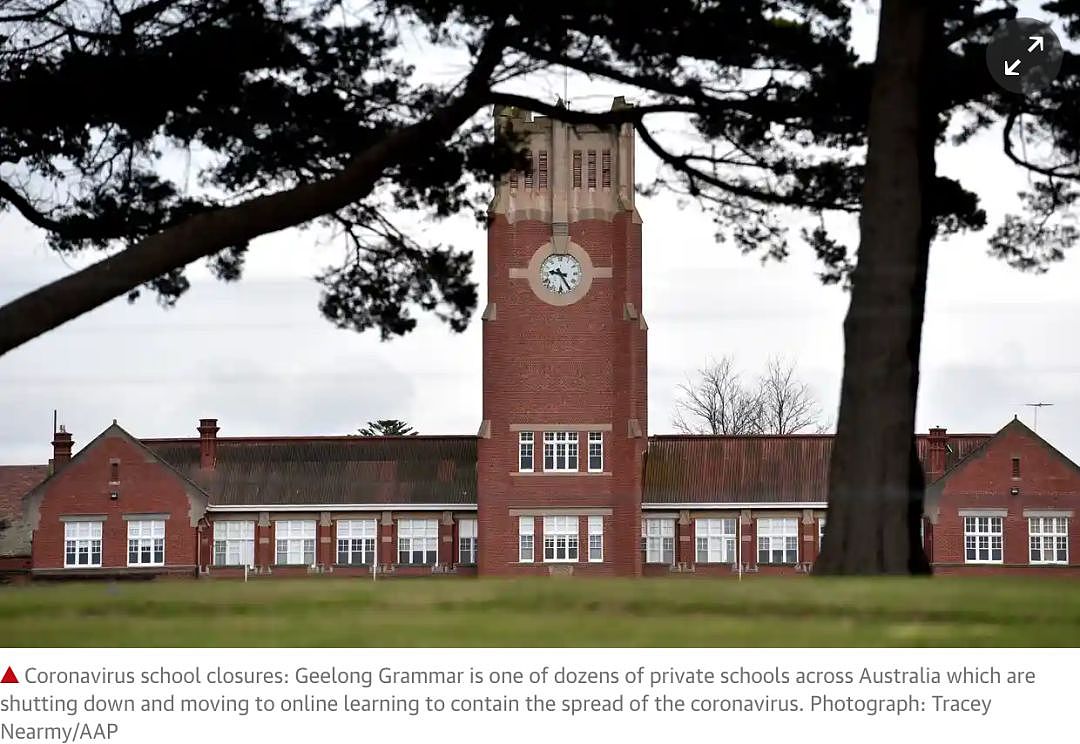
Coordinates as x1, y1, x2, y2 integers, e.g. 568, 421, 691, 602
0, 99, 1080, 578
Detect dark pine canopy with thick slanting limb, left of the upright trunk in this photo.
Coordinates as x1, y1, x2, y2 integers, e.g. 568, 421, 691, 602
0, 0, 977, 353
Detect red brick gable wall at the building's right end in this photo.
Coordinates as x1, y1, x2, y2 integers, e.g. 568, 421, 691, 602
928, 425, 1080, 573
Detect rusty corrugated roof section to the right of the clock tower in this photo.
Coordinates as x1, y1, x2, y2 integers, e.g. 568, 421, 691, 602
643, 434, 991, 503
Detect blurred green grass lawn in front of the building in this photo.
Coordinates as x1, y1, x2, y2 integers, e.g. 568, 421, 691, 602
0, 578, 1080, 647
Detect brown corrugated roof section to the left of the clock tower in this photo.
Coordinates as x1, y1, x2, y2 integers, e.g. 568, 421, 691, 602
143, 436, 476, 506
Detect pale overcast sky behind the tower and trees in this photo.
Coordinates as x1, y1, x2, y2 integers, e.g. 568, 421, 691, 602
0, 1, 1080, 464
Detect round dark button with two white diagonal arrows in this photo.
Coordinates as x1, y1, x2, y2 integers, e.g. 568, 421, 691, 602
986, 18, 1062, 95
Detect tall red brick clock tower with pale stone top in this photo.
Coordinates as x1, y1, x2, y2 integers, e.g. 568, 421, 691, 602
477, 97, 648, 576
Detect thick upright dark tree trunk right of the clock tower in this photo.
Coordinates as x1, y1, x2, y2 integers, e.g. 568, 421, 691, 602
813, 0, 942, 574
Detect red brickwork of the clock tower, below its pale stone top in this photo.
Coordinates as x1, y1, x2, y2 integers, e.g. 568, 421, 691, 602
477, 214, 648, 576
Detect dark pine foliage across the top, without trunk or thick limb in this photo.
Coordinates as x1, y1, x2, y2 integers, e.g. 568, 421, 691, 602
0, 0, 1080, 345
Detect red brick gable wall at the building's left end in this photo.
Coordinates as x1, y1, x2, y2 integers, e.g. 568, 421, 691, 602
32, 434, 201, 570
